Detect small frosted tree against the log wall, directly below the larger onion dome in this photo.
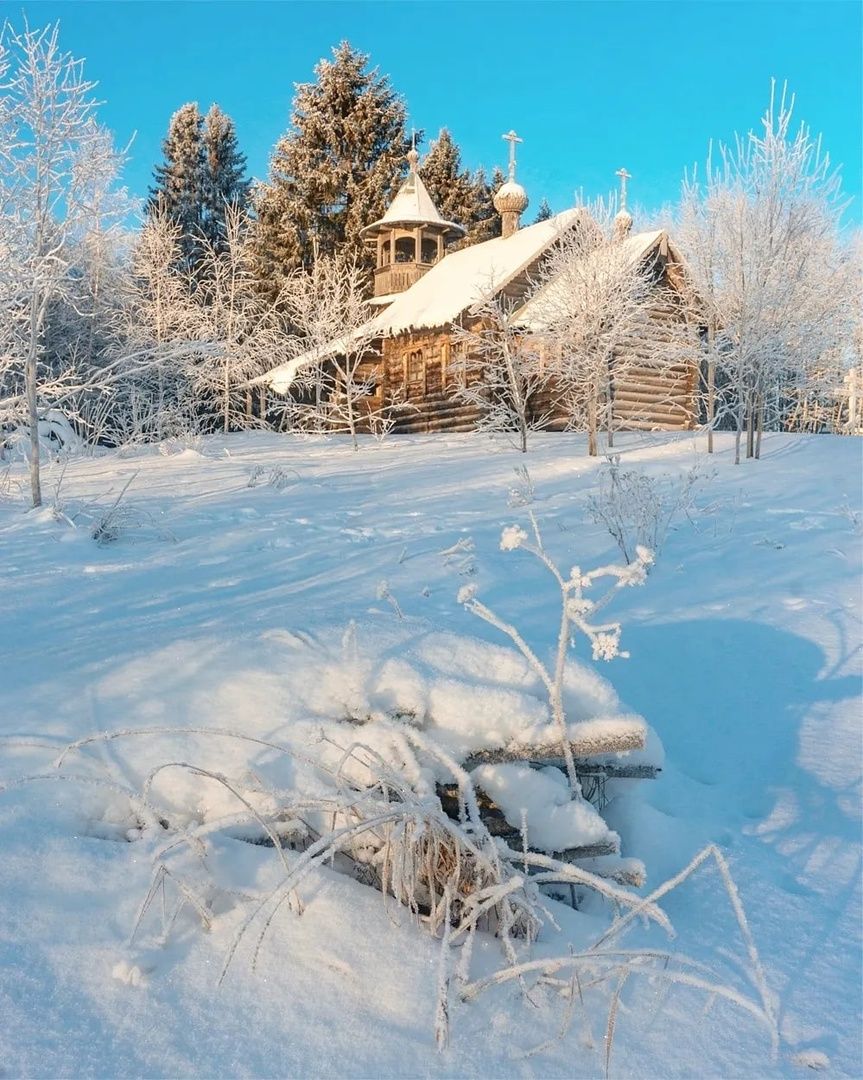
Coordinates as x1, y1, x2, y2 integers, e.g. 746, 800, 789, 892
453, 296, 549, 454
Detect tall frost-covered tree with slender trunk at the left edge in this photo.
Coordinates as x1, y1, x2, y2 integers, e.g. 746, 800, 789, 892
0, 25, 125, 507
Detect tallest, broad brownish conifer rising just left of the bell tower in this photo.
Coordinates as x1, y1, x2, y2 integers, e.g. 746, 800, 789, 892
255, 41, 410, 288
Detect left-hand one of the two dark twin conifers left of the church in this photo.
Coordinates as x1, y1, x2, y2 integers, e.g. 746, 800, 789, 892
148, 102, 206, 271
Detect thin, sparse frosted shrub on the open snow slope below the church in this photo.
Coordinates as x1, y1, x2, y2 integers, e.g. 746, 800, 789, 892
588, 454, 702, 564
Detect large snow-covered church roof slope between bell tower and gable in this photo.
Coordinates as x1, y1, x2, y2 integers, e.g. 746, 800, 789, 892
373, 210, 583, 337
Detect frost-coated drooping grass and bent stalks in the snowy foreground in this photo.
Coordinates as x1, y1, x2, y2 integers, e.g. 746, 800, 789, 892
0, 719, 778, 1074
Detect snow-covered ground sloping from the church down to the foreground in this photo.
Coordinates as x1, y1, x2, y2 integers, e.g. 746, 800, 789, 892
0, 434, 863, 1077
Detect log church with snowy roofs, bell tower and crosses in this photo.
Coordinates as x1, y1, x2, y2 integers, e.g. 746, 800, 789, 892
256, 132, 698, 433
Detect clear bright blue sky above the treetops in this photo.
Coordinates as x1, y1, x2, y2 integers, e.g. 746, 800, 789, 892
8, 0, 863, 218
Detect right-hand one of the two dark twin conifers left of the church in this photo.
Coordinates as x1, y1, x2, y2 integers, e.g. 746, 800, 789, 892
202, 105, 251, 252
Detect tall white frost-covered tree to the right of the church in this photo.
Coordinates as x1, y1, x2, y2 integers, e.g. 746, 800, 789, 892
679, 86, 854, 461
